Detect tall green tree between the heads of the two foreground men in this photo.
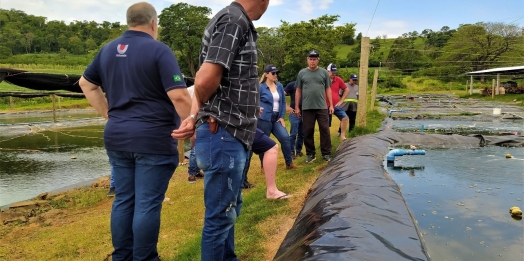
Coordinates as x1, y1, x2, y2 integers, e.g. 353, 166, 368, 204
158, 3, 211, 77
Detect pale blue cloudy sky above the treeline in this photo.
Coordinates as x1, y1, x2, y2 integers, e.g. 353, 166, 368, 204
0, 0, 524, 38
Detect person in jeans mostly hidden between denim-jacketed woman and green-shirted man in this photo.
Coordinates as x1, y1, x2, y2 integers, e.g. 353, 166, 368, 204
284, 81, 304, 159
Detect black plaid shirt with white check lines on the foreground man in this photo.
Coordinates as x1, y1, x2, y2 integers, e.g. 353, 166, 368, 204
197, 2, 260, 149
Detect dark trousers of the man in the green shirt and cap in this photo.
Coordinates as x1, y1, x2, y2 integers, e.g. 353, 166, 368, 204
302, 109, 331, 155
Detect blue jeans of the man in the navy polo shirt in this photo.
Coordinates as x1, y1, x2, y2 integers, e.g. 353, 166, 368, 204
107, 150, 178, 261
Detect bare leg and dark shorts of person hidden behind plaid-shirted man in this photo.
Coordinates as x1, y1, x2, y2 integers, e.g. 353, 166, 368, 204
244, 129, 292, 199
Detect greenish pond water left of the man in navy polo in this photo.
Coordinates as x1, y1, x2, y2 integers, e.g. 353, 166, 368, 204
0, 125, 110, 206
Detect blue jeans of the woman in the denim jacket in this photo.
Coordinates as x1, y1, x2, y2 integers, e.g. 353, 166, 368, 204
257, 112, 293, 165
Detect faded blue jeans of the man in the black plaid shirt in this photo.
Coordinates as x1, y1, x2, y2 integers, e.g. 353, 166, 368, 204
195, 123, 248, 261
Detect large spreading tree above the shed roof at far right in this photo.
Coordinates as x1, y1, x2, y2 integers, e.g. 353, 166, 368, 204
437, 22, 524, 72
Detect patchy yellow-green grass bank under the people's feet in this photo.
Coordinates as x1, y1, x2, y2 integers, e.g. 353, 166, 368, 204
0, 111, 384, 261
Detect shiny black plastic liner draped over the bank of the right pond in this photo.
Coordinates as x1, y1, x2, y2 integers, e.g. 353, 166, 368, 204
274, 119, 524, 261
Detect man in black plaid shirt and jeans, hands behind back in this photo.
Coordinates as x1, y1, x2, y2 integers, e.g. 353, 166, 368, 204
172, 0, 269, 261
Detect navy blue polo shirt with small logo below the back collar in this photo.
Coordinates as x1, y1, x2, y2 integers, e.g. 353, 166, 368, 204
83, 30, 186, 155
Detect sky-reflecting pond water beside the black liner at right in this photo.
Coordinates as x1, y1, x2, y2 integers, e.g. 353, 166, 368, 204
387, 147, 524, 261
